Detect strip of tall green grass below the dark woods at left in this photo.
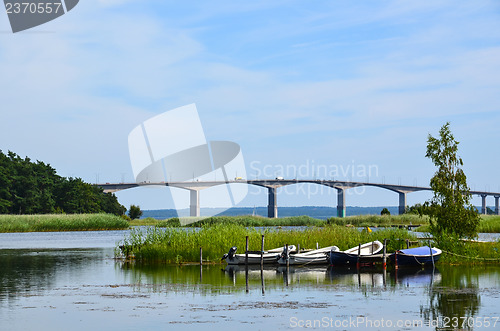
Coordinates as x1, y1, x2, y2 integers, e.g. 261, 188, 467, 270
0, 214, 129, 232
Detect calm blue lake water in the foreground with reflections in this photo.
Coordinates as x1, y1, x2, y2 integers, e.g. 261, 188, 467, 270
0, 231, 500, 331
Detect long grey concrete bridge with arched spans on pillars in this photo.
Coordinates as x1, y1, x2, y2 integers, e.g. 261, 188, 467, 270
96, 179, 500, 218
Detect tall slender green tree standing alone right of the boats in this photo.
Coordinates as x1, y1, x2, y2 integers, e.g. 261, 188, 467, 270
425, 122, 479, 241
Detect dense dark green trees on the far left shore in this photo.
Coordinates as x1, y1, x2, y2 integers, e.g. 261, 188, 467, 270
0, 150, 126, 215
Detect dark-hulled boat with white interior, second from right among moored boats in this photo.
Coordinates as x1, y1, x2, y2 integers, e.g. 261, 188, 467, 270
328, 240, 384, 265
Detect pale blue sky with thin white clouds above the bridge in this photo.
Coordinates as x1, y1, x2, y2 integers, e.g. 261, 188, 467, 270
0, 0, 500, 209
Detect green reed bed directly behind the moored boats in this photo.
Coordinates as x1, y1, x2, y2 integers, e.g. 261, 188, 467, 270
118, 224, 415, 263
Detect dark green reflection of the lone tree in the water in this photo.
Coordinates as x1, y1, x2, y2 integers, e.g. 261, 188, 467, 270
420, 266, 481, 329
